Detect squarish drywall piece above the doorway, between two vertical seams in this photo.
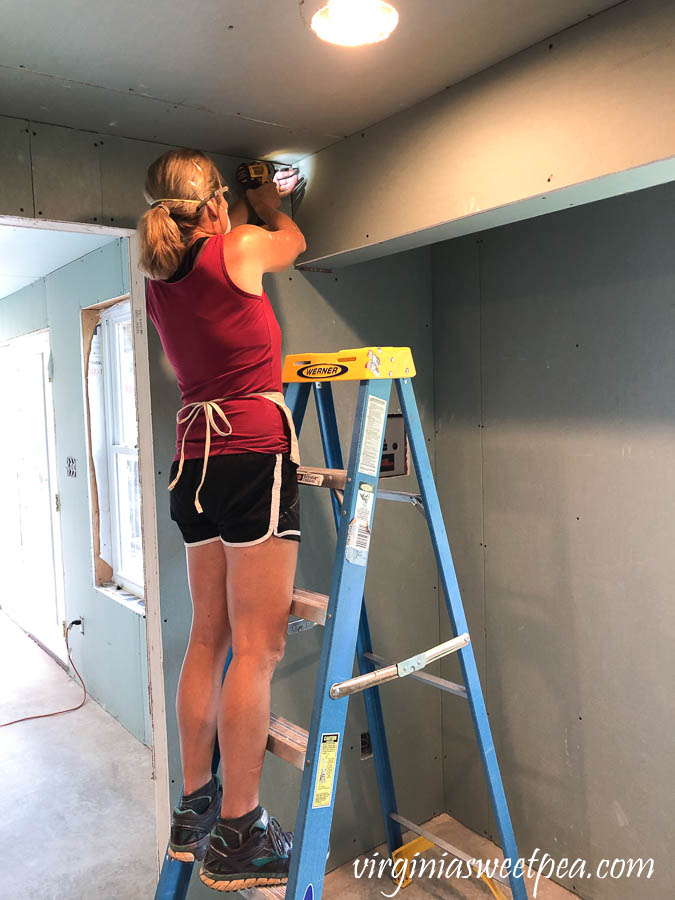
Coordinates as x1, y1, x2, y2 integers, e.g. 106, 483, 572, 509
30, 122, 102, 224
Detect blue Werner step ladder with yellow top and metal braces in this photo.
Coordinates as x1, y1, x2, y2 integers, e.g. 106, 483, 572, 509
155, 347, 527, 900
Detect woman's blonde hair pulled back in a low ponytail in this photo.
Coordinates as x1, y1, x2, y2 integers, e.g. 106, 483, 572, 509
138, 150, 222, 279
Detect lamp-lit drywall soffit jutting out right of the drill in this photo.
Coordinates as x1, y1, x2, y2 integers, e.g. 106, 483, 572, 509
297, 0, 675, 265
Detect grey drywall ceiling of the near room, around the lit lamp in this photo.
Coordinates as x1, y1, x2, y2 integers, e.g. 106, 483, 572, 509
0, 0, 616, 161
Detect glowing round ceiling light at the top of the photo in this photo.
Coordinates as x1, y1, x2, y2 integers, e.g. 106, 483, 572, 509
312, 0, 398, 47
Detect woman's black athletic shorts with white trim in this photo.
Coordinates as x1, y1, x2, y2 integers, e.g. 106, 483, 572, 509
170, 453, 300, 547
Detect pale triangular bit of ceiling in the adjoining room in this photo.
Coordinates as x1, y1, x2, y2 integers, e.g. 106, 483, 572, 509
0, 225, 116, 299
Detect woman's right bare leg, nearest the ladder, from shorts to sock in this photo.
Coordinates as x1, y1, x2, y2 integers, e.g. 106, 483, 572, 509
218, 537, 298, 819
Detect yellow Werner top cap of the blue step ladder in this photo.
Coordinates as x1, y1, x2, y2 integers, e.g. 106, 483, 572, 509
281, 347, 415, 383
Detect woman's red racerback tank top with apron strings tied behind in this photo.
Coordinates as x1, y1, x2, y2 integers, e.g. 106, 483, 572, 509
147, 234, 289, 459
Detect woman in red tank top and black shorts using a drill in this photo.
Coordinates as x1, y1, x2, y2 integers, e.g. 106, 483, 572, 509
139, 150, 305, 891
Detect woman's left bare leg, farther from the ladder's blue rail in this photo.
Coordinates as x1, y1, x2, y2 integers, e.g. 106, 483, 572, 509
176, 540, 231, 794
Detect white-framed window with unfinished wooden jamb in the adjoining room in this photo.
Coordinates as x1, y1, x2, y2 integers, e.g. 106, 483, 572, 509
83, 301, 144, 596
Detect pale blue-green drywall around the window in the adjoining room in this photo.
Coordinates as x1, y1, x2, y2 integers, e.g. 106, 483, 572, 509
0, 239, 151, 745
